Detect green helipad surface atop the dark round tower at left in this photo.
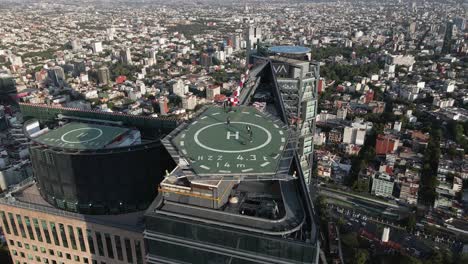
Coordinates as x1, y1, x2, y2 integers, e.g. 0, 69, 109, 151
36, 123, 129, 150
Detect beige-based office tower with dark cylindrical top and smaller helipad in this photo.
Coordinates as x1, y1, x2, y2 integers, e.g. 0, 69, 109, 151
0, 104, 177, 264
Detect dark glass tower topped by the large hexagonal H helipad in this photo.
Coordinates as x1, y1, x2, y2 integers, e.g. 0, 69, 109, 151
144, 105, 319, 264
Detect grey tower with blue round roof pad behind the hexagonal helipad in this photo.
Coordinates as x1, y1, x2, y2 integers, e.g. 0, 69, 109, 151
253, 45, 320, 184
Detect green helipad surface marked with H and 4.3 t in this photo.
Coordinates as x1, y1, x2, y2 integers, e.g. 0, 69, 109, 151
173, 107, 287, 175
